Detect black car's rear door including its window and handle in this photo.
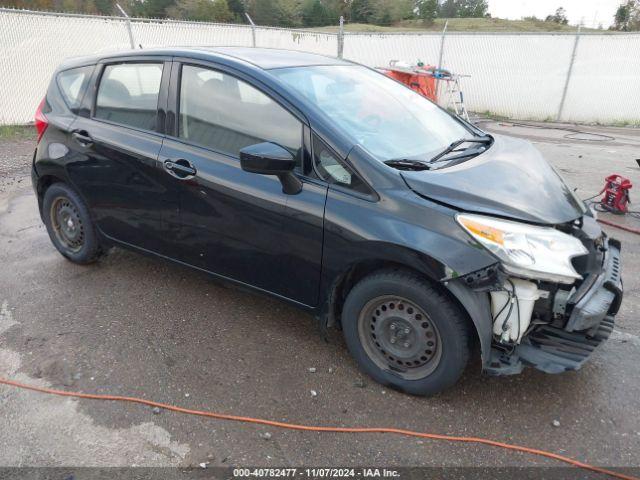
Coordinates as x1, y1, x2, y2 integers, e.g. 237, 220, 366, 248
67, 57, 179, 255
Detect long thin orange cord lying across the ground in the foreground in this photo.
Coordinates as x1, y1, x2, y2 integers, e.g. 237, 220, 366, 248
0, 377, 640, 480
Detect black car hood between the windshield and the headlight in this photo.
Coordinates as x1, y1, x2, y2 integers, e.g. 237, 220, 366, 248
401, 135, 585, 224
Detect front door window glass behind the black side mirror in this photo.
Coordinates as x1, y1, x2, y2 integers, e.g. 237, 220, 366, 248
178, 65, 302, 158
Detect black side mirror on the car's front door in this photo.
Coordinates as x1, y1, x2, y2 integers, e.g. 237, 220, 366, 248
240, 142, 302, 195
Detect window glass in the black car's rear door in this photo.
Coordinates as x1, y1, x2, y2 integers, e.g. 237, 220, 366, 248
95, 63, 162, 130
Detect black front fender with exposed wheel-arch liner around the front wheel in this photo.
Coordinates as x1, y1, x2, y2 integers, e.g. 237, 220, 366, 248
319, 187, 496, 365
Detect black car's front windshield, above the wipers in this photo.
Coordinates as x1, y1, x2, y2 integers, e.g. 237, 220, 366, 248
271, 65, 471, 161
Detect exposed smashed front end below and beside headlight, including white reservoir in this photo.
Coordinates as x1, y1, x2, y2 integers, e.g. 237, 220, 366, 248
469, 216, 623, 375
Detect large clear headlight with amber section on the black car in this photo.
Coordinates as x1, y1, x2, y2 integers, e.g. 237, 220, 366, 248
456, 214, 589, 284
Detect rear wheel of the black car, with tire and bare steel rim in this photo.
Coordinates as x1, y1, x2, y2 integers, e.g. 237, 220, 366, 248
42, 183, 102, 265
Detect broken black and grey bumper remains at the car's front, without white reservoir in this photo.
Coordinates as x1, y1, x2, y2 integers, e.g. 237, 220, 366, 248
485, 239, 623, 375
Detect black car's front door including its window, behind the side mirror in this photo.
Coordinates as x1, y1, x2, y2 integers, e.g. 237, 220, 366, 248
160, 64, 327, 306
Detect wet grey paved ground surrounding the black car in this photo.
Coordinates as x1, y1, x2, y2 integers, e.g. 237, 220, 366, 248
0, 122, 640, 474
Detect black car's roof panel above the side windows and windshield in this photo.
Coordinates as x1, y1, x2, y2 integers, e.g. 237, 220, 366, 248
61, 46, 351, 70
